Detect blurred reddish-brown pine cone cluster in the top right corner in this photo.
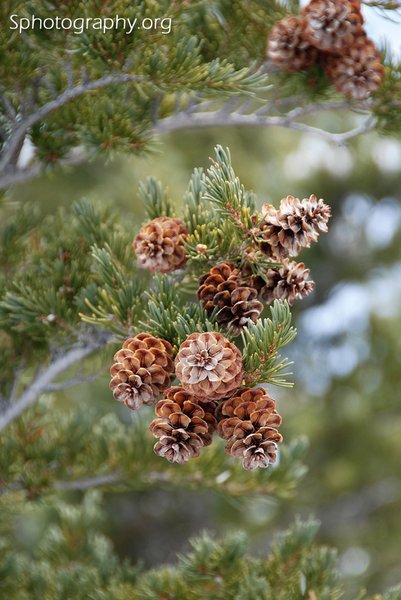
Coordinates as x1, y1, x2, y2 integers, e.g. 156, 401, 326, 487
267, 0, 384, 100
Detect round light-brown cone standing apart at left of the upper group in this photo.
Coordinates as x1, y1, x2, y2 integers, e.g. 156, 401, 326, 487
132, 217, 188, 273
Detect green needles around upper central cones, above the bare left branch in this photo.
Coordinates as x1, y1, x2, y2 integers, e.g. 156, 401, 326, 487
0, 147, 295, 392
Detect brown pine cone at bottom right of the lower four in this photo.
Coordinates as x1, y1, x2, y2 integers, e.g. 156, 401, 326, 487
218, 387, 283, 470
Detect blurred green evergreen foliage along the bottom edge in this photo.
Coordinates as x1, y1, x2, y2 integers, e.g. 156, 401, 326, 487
0, 491, 401, 600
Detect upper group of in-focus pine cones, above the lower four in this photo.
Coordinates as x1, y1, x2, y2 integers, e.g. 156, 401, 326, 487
133, 195, 330, 322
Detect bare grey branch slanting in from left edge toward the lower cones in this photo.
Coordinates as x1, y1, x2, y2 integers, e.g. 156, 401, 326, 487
0, 336, 109, 432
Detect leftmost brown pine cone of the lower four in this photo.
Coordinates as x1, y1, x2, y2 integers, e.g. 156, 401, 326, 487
110, 333, 174, 410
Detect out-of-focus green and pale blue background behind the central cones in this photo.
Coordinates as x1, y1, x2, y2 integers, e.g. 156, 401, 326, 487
1, 114, 401, 600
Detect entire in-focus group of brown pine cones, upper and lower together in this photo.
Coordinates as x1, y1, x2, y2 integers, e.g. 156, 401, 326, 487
110, 196, 330, 469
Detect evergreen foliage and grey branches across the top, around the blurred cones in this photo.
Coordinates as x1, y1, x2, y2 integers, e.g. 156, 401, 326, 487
0, 0, 400, 188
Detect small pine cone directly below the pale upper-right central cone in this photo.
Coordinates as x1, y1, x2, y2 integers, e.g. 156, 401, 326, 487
260, 260, 315, 305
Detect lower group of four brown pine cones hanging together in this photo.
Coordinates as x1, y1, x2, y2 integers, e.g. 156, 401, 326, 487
110, 332, 282, 469
